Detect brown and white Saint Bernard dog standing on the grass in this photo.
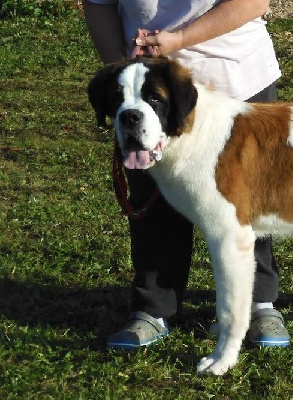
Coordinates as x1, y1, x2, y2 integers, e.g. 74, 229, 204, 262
88, 58, 293, 375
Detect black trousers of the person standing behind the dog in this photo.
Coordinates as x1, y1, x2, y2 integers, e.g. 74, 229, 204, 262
126, 84, 279, 318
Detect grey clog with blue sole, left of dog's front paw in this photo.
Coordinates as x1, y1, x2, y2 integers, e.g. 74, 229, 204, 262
107, 311, 169, 350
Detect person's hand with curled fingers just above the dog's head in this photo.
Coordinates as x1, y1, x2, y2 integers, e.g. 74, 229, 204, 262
131, 29, 183, 58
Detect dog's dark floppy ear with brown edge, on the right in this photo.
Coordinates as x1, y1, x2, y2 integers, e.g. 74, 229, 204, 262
168, 61, 198, 135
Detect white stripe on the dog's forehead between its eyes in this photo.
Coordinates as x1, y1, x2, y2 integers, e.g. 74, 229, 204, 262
118, 63, 148, 101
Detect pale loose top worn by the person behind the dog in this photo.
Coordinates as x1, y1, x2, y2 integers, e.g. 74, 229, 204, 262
90, 0, 281, 100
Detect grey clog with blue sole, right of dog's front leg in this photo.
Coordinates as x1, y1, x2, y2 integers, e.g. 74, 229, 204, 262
247, 308, 290, 347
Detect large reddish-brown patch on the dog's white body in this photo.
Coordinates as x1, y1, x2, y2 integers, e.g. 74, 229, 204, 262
216, 103, 293, 225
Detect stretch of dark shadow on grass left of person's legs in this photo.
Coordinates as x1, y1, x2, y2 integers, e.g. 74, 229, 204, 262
0, 278, 130, 350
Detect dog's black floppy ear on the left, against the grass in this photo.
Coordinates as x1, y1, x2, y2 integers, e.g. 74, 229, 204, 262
88, 64, 120, 127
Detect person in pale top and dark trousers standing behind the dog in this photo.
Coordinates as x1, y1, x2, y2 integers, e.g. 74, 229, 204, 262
83, 0, 290, 349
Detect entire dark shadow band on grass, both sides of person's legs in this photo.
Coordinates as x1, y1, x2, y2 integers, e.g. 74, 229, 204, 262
0, 278, 293, 350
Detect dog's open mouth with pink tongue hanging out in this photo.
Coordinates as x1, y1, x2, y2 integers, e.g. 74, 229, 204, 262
122, 141, 162, 169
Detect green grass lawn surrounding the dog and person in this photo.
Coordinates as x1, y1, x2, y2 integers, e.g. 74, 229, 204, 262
0, 9, 293, 400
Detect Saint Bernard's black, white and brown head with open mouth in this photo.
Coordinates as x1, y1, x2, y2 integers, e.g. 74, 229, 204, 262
88, 58, 197, 169
